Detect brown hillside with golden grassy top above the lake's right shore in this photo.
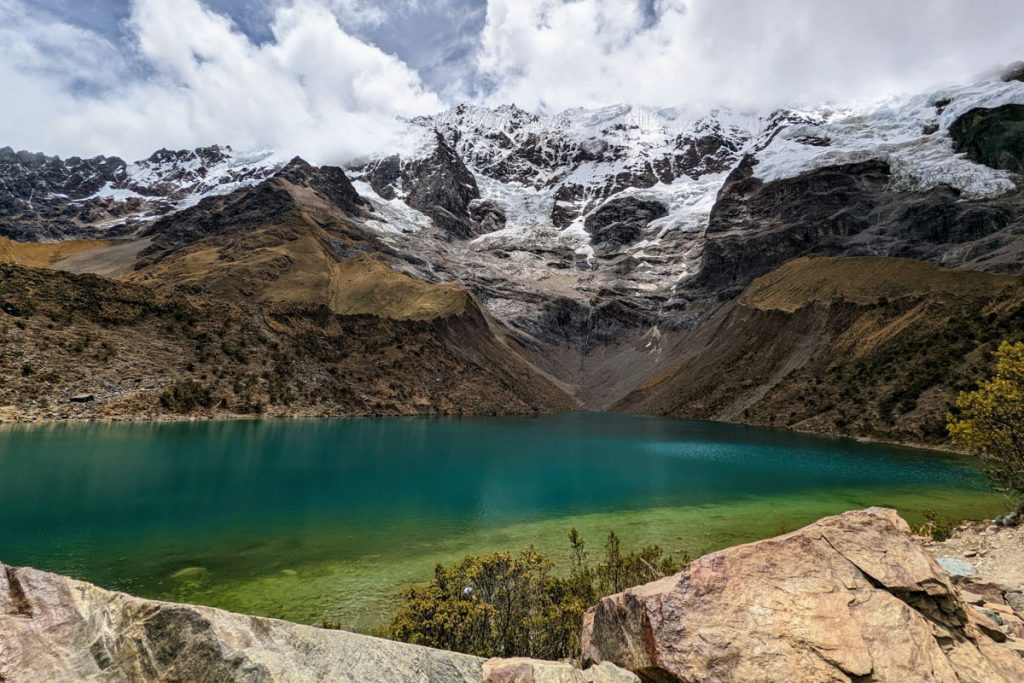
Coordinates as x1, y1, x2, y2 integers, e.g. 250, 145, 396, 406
617, 258, 1024, 443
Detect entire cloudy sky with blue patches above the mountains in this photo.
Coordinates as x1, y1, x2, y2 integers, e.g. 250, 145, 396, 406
0, 0, 1024, 162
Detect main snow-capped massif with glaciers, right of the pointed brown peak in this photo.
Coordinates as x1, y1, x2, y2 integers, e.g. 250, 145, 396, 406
337, 70, 1024, 339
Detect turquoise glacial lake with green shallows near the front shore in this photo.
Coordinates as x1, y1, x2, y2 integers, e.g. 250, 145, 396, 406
0, 414, 1006, 631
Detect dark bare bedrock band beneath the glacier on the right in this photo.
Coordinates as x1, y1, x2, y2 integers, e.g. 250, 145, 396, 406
687, 157, 1024, 298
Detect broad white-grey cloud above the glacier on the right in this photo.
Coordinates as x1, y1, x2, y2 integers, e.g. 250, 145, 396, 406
477, 0, 1024, 111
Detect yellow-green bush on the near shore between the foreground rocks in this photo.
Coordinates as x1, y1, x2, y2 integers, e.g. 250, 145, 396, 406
382, 528, 688, 659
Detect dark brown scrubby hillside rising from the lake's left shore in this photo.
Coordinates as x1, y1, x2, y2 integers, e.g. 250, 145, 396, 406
0, 264, 571, 419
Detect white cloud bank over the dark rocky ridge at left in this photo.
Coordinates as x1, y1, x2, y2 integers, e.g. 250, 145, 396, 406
0, 0, 442, 162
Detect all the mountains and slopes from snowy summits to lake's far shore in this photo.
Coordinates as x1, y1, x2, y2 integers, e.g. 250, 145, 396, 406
0, 69, 1024, 443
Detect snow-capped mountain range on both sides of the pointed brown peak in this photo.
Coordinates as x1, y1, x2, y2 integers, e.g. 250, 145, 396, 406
0, 70, 1024, 352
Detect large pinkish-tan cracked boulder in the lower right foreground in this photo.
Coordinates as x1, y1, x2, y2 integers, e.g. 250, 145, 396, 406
583, 508, 1024, 683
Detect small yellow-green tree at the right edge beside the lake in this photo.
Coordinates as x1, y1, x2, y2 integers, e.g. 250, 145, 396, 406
947, 342, 1024, 509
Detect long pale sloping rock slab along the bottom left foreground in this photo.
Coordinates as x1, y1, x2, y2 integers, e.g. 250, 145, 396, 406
0, 564, 637, 683
